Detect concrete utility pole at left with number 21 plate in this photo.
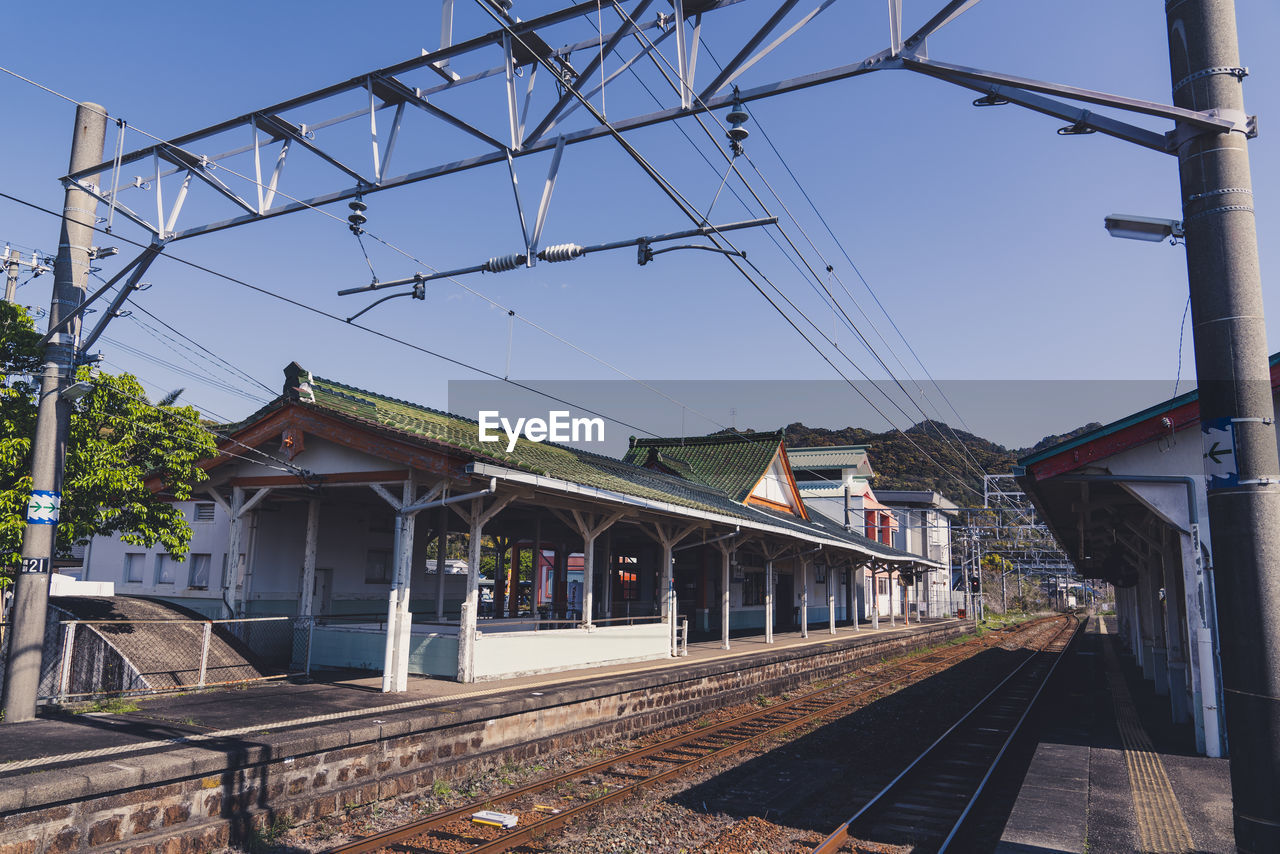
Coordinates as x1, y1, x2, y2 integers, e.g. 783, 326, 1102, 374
4, 104, 106, 723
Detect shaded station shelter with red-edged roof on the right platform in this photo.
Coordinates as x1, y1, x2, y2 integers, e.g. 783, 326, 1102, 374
1018, 355, 1280, 757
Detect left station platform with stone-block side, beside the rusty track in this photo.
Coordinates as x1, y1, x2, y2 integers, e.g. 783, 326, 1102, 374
0, 620, 972, 854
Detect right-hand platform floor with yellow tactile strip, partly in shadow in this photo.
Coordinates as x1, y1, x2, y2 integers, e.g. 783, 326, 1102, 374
996, 617, 1235, 854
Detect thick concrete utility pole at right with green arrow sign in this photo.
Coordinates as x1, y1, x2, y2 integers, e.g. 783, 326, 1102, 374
1165, 0, 1280, 851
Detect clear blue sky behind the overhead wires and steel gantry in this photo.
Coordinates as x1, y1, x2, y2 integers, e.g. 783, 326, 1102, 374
0, 0, 1280, 453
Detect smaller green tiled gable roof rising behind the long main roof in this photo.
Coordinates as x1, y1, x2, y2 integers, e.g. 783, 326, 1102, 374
622, 430, 782, 502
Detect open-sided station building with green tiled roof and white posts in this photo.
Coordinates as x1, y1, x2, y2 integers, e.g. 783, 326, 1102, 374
84, 364, 943, 691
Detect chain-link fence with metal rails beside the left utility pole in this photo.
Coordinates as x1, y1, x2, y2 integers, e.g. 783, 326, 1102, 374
16, 617, 311, 703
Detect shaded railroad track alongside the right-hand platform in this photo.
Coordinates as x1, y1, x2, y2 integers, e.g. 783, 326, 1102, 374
813, 616, 1080, 854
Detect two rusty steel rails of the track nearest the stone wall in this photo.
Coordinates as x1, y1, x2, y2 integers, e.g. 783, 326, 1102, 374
326, 621, 1042, 854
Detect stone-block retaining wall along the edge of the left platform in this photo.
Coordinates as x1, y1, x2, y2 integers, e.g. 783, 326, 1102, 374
0, 622, 965, 854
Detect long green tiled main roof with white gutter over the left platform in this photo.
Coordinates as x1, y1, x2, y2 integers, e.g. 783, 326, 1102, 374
214, 364, 928, 563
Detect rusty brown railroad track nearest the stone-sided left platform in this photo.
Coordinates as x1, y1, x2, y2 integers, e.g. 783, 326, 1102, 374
329, 621, 1039, 854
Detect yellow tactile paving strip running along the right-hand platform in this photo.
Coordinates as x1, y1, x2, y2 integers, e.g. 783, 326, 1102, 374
1098, 618, 1196, 854
